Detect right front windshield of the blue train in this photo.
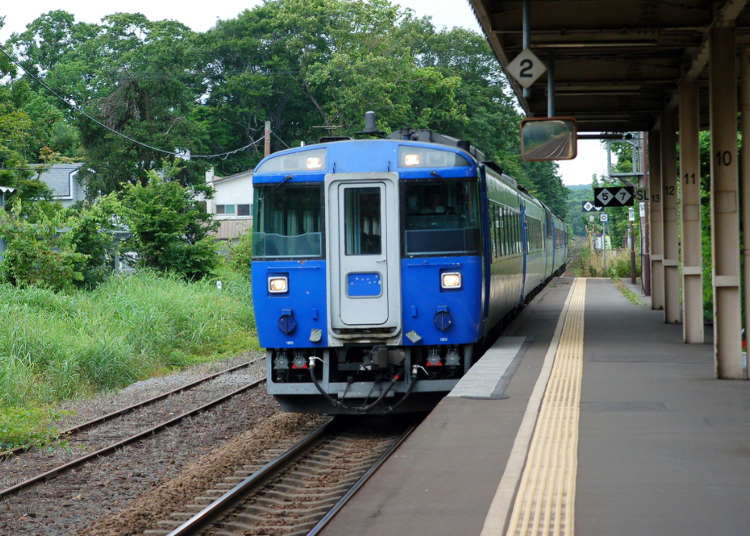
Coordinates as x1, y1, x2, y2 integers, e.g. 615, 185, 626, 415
403, 180, 479, 255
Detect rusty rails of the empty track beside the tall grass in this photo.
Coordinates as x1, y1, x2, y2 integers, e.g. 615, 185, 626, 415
0, 358, 265, 500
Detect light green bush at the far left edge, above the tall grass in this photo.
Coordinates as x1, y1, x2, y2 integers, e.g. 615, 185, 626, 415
0, 201, 86, 291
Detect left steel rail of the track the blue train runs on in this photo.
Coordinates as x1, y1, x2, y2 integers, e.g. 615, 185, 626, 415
167, 418, 337, 536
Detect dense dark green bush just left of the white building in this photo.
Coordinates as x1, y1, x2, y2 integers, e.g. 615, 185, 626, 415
122, 163, 219, 280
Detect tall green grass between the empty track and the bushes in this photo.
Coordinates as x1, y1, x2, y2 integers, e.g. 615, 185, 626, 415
0, 271, 258, 407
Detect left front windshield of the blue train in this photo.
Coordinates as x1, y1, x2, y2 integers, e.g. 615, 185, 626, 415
253, 183, 323, 258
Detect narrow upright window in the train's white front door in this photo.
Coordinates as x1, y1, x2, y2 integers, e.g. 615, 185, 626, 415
344, 188, 383, 255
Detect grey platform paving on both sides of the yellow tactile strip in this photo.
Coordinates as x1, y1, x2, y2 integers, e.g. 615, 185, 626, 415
323, 278, 750, 536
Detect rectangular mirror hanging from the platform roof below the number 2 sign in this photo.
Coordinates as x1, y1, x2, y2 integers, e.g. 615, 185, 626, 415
521, 117, 578, 162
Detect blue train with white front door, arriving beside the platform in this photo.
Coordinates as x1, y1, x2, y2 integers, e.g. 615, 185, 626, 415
252, 129, 567, 413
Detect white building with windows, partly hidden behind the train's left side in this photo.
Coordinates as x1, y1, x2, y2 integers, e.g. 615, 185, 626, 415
206, 168, 253, 240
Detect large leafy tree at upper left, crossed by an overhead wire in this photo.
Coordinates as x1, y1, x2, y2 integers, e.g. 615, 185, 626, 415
12, 11, 212, 193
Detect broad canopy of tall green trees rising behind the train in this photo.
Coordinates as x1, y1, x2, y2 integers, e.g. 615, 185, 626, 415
0, 0, 567, 218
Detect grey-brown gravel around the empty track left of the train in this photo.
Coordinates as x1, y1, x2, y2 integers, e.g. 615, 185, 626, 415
0, 356, 279, 535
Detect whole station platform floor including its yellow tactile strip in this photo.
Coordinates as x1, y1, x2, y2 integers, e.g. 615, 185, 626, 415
323, 278, 750, 536
